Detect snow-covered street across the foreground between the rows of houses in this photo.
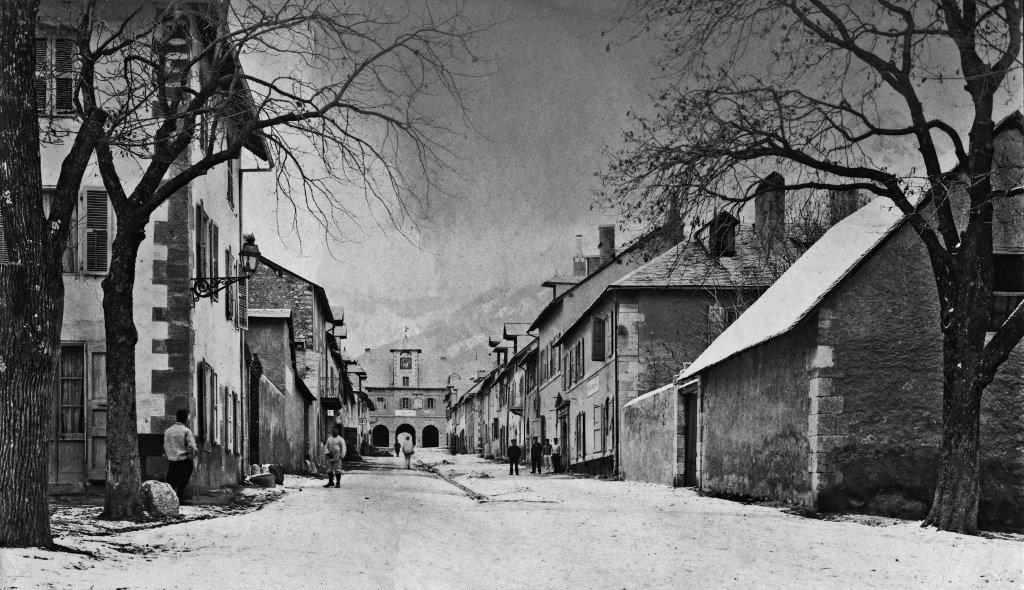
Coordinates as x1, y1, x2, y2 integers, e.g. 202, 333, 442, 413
0, 450, 1024, 588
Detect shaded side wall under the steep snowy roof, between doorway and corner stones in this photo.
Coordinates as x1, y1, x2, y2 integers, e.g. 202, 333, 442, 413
700, 322, 816, 506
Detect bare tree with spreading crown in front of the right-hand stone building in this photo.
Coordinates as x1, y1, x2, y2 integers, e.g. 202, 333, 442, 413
605, 0, 1024, 533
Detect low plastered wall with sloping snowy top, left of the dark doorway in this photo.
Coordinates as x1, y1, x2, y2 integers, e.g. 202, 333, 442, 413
620, 384, 678, 486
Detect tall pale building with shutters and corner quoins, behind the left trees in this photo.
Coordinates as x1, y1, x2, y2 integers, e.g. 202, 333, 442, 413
0, 2, 268, 491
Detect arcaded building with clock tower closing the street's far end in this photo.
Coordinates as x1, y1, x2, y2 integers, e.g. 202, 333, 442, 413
357, 339, 455, 449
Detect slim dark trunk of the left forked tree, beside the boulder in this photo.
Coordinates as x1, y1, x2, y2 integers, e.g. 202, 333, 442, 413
102, 217, 145, 520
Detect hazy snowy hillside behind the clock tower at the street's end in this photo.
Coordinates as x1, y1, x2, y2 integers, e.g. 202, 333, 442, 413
358, 286, 551, 389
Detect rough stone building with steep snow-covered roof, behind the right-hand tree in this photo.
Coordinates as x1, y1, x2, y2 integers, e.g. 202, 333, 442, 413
673, 113, 1024, 526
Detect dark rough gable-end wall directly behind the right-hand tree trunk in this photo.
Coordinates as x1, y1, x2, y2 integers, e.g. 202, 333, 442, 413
819, 219, 1024, 525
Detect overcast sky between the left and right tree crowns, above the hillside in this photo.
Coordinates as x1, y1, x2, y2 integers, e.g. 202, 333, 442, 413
245, 0, 654, 352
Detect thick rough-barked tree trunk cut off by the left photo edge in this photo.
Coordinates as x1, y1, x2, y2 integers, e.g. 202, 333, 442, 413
0, 0, 57, 547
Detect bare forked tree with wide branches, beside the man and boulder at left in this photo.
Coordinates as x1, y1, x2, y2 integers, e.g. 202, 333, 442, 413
0, 0, 470, 538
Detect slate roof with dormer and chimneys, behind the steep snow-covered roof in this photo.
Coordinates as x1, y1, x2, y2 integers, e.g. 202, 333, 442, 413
609, 223, 802, 289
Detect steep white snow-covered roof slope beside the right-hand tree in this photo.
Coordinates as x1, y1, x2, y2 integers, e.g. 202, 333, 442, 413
680, 198, 903, 379
